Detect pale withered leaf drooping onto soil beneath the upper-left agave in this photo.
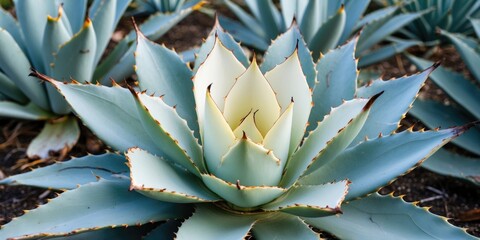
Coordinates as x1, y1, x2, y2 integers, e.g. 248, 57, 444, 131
27, 116, 80, 158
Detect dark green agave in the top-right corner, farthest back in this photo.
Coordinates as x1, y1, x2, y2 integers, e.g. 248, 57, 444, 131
378, 0, 480, 45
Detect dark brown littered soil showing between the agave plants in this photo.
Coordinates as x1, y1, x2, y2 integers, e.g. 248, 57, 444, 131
0, 7, 480, 236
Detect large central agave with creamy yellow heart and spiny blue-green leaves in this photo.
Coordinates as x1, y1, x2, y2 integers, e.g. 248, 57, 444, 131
0, 21, 474, 239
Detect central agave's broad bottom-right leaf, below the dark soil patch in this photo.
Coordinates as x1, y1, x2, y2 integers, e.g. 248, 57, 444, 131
304, 194, 477, 239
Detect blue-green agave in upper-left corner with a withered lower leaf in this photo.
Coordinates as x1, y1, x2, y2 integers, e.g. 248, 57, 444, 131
0, 0, 201, 157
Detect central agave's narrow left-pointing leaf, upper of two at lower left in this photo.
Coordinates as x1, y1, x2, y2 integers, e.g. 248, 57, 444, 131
0, 153, 129, 189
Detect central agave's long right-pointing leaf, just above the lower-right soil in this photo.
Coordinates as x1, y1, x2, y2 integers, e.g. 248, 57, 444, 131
299, 127, 466, 200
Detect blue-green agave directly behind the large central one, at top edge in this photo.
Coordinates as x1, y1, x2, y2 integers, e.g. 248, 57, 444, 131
216, 0, 423, 67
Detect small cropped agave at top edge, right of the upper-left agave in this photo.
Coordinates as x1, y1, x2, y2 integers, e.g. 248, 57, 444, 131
128, 0, 200, 15
